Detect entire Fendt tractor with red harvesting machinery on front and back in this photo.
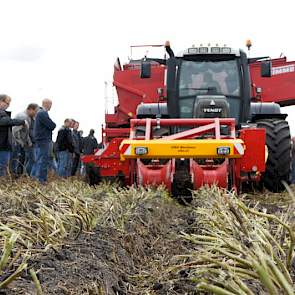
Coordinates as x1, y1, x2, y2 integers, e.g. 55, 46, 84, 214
83, 42, 295, 197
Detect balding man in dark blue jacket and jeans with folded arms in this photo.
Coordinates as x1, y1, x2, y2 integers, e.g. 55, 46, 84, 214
33, 99, 56, 184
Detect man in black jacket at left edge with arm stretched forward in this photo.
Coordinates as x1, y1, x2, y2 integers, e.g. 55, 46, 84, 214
0, 94, 25, 176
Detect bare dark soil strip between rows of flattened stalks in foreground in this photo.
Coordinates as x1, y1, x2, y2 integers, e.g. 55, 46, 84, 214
0, 186, 196, 294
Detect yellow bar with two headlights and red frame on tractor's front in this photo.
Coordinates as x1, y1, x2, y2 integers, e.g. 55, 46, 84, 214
120, 118, 245, 160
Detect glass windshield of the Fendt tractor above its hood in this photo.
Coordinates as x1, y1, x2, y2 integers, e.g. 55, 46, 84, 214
179, 59, 241, 120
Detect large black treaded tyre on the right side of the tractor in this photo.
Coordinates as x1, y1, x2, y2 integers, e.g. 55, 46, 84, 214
256, 118, 292, 193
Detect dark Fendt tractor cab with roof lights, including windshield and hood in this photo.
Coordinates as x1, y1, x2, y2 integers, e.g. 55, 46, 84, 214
167, 43, 251, 124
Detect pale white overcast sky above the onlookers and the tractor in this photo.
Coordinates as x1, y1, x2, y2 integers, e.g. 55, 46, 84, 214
0, 0, 295, 138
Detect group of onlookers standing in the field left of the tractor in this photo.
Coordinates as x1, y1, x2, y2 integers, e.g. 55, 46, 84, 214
0, 94, 99, 183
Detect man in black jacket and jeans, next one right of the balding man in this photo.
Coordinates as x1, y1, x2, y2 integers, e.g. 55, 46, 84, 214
56, 119, 74, 177
